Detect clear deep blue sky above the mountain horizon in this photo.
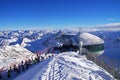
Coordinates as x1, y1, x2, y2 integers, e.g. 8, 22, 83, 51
0, 0, 120, 30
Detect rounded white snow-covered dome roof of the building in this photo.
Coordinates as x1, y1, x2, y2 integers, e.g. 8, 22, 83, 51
80, 32, 104, 45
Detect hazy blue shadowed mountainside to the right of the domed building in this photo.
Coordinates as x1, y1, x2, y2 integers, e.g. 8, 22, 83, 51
91, 31, 120, 67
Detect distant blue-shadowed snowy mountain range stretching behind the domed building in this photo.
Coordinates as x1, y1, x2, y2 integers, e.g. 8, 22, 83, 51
0, 28, 120, 67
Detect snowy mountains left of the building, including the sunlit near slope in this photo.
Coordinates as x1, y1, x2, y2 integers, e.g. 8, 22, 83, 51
0, 30, 57, 70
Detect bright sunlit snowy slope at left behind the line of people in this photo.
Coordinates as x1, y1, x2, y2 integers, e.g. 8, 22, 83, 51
0, 45, 36, 69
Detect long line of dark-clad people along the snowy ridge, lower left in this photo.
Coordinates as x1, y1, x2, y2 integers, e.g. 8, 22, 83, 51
0, 54, 53, 80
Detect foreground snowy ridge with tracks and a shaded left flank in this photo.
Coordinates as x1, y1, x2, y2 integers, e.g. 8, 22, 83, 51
15, 52, 114, 80
